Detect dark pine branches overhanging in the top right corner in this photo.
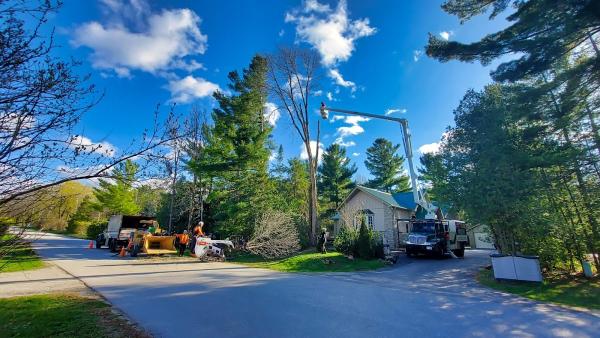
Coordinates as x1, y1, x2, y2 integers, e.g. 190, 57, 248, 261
427, 0, 600, 81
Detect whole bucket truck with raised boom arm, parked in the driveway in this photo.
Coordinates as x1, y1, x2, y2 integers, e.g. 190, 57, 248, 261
320, 102, 467, 257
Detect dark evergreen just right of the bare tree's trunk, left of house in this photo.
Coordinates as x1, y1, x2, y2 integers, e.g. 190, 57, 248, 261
317, 143, 357, 214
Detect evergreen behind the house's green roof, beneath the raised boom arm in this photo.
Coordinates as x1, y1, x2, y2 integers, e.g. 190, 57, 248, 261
365, 138, 410, 193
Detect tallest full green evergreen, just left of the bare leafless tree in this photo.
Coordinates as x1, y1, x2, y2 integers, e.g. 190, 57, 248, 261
189, 56, 273, 236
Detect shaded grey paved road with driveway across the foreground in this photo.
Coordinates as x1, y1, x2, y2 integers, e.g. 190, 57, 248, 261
29, 235, 600, 338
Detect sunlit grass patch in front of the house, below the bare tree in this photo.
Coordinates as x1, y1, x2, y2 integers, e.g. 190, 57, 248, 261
228, 251, 385, 272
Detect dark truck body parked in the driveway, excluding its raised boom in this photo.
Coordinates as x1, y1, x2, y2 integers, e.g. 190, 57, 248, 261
405, 219, 468, 257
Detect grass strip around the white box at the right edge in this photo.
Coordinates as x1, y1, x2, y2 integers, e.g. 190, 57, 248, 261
477, 269, 600, 310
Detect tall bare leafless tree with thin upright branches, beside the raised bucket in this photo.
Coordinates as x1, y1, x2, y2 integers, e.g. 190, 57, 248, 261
268, 48, 320, 244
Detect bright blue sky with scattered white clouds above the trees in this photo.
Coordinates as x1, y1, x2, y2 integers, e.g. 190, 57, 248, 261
44, 0, 506, 177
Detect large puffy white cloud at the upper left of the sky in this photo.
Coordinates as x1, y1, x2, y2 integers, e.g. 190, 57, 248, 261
71, 0, 207, 77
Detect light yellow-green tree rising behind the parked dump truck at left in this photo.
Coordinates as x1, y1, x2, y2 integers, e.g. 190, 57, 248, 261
94, 160, 140, 215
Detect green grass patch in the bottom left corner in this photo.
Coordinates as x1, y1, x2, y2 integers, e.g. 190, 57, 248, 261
0, 294, 146, 337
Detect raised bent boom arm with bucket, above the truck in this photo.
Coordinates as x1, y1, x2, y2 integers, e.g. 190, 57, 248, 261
321, 102, 437, 219
